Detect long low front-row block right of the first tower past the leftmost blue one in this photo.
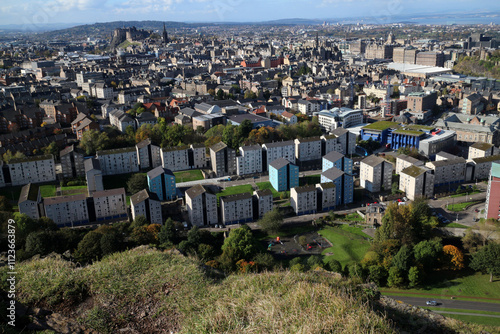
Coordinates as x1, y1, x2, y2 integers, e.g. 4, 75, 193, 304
220, 193, 253, 225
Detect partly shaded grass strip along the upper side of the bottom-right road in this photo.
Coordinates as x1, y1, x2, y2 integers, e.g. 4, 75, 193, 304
380, 271, 500, 303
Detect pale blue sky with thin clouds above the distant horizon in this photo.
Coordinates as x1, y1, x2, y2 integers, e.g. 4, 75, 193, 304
0, 0, 500, 26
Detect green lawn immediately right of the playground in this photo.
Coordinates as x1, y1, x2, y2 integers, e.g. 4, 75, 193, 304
318, 225, 370, 266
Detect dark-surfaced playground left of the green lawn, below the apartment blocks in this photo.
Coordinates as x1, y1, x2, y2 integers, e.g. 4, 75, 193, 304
266, 231, 332, 260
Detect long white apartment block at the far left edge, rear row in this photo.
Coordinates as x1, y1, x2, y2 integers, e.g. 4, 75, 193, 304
8, 154, 56, 186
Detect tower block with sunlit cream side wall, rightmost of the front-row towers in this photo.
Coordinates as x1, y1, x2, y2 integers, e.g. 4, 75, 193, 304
399, 166, 434, 201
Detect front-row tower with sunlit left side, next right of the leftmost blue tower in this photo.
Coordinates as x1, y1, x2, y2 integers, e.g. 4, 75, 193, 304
186, 184, 219, 226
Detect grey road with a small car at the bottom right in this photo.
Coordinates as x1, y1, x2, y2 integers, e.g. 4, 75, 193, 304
384, 294, 500, 313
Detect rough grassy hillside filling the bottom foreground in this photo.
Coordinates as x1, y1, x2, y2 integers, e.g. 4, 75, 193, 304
0, 246, 493, 333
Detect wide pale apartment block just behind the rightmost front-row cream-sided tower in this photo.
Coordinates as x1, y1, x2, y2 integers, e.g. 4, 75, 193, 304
425, 158, 466, 187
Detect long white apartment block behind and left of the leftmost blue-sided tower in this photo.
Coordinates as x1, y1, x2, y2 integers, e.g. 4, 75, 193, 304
97, 146, 139, 175
